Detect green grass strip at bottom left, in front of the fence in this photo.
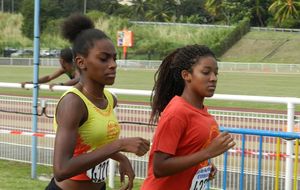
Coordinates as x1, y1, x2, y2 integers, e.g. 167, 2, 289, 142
0, 160, 143, 190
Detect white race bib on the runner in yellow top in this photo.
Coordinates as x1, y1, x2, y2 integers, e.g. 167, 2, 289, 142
86, 159, 109, 183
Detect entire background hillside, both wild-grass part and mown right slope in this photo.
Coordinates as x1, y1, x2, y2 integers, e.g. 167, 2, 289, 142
0, 12, 300, 64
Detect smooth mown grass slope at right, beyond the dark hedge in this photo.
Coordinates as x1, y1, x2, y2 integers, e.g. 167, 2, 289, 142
220, 31, 300, 64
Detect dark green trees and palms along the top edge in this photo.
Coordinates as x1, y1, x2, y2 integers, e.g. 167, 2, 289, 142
3, 0, 300, 28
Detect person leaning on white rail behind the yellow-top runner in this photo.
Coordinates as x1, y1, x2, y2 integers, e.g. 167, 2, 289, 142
21, 48, 80, 90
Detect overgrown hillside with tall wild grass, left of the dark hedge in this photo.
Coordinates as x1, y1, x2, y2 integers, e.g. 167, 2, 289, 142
0, 12, 234, 60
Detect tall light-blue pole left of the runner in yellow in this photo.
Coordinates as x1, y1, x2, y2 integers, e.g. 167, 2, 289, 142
31, 0, 40, 179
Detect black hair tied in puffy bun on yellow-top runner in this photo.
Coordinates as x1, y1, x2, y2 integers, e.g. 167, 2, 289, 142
62, 13, 110, 58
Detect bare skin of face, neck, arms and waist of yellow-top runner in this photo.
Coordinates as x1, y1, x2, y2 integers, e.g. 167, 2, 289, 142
54, 39, 150, 190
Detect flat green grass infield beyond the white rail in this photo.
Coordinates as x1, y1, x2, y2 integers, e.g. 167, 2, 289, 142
0, 66, 300, 111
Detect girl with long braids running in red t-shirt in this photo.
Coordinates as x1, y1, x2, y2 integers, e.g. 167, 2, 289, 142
141, 45, 235, 190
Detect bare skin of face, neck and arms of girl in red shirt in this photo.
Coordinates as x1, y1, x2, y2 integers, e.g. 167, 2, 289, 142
153, 57, 235, 179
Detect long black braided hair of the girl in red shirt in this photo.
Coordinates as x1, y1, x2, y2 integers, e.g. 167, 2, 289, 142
150, 44, 216, 124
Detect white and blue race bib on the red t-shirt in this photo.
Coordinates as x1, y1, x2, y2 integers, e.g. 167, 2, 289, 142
190, 166, 211, 190
